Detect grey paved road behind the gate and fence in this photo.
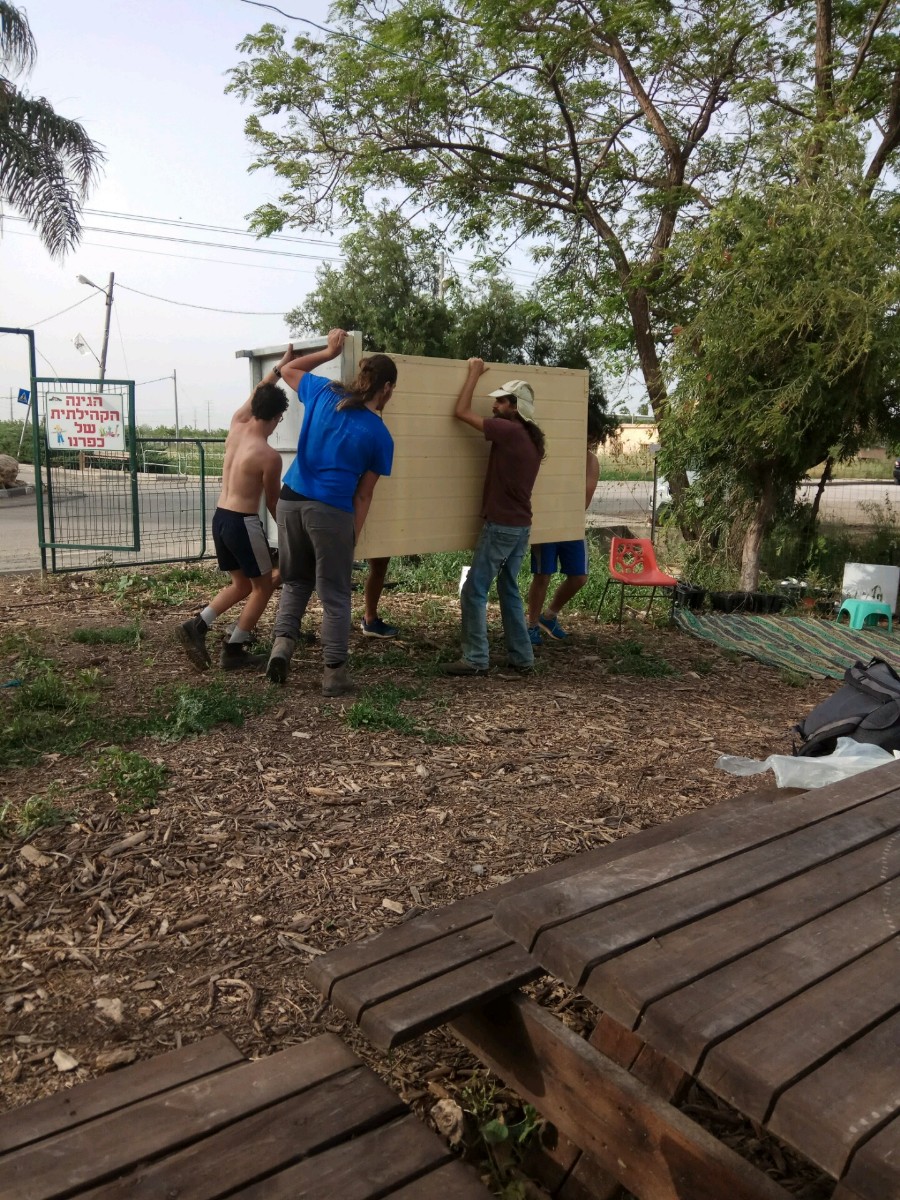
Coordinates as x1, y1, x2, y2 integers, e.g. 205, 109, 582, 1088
0, 467, 900, 571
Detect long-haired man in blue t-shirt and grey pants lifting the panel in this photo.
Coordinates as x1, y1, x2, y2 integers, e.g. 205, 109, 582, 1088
265, 329, 397, 696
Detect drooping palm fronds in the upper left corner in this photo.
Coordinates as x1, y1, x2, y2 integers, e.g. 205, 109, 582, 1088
0, 0, 103, 258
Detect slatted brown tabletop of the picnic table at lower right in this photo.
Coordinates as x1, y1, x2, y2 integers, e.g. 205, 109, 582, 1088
494, 763, 900, 1200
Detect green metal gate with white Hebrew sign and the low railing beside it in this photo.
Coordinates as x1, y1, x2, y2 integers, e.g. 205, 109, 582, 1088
32, 379, 224, 571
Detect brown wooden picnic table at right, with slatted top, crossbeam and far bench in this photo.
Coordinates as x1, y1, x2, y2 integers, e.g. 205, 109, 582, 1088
310, 763, 900, 1200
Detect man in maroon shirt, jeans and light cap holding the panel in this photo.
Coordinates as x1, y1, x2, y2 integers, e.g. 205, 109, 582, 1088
443, 359, 544, 676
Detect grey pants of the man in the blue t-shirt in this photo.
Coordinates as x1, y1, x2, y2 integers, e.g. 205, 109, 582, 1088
275, 500, 355, 664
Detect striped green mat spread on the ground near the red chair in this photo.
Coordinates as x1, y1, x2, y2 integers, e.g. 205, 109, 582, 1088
676, 608, 900, 679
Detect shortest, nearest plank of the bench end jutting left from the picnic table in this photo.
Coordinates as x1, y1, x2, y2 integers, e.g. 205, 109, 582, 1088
359, 946, 544, 1050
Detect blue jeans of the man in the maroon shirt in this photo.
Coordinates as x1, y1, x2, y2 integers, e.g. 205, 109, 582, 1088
460, 521, 534, 667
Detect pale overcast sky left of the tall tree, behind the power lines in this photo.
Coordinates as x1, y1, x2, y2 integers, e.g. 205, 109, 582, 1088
0, 0, 348, 426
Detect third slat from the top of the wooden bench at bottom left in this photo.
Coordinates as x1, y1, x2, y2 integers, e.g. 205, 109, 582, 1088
79, 1063, 405, 1200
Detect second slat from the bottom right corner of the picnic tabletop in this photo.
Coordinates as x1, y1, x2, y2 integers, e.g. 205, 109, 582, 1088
768, 1013, 900, 1178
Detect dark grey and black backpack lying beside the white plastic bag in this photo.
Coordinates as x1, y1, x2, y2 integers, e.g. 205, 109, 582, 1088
793, 659, 900, 757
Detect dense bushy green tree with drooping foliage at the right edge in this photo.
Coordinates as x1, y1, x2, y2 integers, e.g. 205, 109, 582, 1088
660, 138, 900, 589
